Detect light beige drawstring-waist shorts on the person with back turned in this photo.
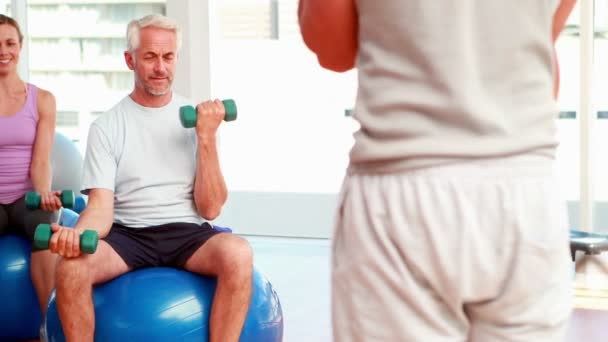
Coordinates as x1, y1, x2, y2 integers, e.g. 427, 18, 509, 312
332, 160, 572, 342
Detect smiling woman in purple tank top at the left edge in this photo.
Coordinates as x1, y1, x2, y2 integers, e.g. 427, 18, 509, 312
0, 14, 61, 336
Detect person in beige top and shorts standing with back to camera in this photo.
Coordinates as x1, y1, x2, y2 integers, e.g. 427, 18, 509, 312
298, 0, 575, 342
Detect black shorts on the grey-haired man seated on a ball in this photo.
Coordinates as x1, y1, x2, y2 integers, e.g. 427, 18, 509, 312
104, 222, 221, 269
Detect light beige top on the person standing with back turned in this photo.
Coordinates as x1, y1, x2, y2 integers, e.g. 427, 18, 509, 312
351, 0, 559, 172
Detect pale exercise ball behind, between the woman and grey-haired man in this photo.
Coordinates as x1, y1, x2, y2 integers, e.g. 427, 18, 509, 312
51, 133, 82, 194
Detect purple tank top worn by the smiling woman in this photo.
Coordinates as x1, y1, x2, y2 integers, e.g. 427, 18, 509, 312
0, 84, 38, 204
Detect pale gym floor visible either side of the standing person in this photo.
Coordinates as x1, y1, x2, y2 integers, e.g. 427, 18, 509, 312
246, 236, 608, 342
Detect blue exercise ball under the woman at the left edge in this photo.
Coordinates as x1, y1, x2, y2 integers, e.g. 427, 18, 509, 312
0, 234, 42, 341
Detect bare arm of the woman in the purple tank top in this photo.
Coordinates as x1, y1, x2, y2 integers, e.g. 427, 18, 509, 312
30, 89, 61, 211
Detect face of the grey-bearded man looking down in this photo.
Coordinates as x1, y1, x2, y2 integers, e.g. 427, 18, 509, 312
127, 27, 177, 96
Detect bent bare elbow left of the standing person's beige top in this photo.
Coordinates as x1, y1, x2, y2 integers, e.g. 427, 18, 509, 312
298, 0, 359, 72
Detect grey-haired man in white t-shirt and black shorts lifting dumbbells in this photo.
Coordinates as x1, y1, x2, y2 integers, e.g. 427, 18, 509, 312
50, 15, 253, 342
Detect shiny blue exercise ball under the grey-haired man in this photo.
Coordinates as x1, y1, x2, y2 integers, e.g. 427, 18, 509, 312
46, 267, 283, 342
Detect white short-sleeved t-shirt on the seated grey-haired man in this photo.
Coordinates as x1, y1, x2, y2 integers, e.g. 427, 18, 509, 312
82, 94, 203, 228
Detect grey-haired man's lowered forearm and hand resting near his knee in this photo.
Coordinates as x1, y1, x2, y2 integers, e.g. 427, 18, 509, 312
49, 189, 114, 258
